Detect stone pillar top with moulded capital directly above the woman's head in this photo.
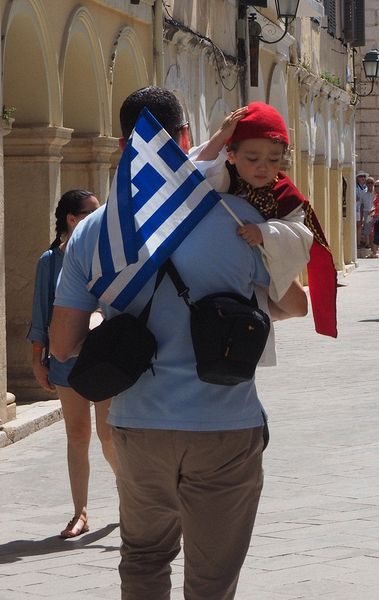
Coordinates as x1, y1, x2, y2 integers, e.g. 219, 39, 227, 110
61, 136, 118, 203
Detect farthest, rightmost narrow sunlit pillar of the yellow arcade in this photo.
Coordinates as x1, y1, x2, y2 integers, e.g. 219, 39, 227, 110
329, 160, 345, 272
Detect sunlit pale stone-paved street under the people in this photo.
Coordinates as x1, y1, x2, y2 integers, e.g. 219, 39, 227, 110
0, 260, 379, 600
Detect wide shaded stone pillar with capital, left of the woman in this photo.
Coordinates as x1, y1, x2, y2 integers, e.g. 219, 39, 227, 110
4, 127, 72, 400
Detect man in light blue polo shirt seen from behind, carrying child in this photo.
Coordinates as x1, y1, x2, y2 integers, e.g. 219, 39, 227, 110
51, 87, 307, 600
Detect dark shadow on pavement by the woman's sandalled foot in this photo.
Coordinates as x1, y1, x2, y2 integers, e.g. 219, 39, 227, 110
0, 523, 119, 564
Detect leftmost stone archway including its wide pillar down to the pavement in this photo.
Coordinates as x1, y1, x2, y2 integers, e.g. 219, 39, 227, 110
3, 0, 70, 399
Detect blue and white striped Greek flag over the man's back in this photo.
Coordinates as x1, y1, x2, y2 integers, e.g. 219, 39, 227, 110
88, 108, 220, 311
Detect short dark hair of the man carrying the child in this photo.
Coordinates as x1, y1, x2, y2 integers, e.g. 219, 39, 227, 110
120, 86, 185, 141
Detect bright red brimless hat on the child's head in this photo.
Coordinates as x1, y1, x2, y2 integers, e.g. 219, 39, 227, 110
228, 102, 289, 146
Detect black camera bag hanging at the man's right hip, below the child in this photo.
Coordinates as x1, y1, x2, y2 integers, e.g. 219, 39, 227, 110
166, 259, 270, 385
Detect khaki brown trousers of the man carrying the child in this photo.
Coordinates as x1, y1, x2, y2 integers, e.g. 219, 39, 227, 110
113, 427, 263, 600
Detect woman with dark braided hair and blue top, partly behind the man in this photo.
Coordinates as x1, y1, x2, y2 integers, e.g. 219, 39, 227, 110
27, 189, 115, 538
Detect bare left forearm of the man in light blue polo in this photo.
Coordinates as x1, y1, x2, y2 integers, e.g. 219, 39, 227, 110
49, 306, 91, 362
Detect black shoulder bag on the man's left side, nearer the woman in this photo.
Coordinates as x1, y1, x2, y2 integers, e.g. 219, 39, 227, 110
68, 268, 165, 402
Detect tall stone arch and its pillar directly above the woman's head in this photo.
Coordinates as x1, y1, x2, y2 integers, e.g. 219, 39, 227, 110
60, 8, 117, 202
